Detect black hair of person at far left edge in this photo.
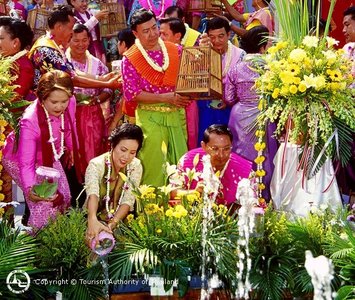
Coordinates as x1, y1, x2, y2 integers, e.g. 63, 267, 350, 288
0, 16, 34, 50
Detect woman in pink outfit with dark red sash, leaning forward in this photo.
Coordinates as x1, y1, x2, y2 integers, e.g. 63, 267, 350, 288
3, 70, 77, 229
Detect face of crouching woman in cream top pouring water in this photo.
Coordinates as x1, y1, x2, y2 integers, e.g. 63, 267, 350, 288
112, 140, 139, 170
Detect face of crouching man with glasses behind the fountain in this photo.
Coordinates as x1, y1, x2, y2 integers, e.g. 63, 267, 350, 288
201, 133, 232, 170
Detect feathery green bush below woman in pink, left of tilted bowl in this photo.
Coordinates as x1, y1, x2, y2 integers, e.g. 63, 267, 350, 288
37, 209, 103, 299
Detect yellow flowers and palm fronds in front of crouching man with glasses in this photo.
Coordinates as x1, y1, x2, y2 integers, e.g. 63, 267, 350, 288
109, 191, 238, 296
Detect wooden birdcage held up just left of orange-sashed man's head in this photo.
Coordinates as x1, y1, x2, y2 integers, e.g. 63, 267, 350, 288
99, 0, 127, 37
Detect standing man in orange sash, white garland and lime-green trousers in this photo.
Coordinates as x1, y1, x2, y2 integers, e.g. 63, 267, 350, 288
122, 9, 190, 186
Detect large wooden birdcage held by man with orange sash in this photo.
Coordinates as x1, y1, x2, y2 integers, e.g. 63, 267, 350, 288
176, 46, 222, 100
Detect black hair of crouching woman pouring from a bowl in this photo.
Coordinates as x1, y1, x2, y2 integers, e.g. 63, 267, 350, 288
109, 123, 143, 152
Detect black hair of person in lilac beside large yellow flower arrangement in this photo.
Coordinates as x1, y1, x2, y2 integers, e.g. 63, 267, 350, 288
239, 25, 270, 53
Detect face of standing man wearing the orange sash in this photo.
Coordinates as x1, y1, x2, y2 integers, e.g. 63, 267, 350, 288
133, 18, 159, 50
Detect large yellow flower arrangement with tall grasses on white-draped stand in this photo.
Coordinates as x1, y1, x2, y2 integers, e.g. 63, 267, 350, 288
255, 0, 355, 177
